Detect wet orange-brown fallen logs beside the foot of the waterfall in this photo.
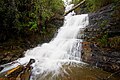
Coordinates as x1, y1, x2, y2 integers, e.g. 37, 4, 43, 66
0, 59, 35, 80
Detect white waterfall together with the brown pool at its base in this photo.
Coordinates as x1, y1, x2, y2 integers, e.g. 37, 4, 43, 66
0, 0, 119, 80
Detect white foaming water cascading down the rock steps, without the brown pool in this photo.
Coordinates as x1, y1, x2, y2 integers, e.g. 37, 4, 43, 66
0, 0, 89, 80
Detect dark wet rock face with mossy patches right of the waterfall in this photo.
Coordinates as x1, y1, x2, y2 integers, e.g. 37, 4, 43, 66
82, 3, 120, 72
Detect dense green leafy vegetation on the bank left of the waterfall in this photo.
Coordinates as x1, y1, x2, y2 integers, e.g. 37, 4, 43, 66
0, 0, 64, 41
